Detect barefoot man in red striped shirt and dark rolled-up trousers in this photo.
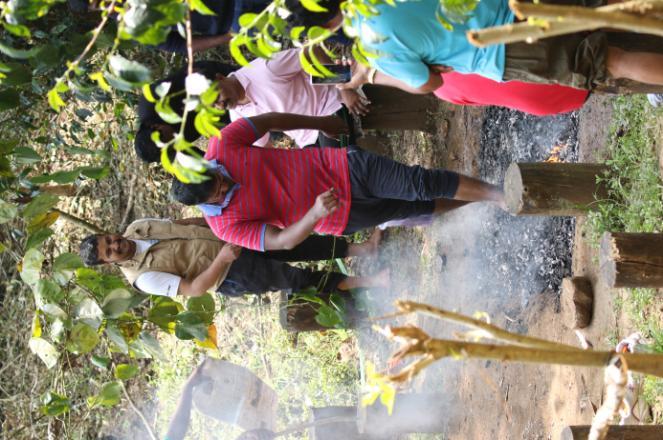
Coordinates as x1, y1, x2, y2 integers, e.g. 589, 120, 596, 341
171, 113, 503, 251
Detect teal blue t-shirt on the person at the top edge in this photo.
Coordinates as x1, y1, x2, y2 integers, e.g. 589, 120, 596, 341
352, 0, 514, 87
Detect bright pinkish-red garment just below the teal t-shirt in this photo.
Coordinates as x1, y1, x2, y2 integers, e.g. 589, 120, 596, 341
435, 72, 589, 116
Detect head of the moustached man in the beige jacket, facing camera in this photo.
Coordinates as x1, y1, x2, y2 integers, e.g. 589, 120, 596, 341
78, 234, 136, 266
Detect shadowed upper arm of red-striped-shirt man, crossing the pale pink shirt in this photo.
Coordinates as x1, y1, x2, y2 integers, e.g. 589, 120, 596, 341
249, 112, 348, 144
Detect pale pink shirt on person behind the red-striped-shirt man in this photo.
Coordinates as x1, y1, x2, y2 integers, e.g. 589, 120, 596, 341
229, 49, 342, 147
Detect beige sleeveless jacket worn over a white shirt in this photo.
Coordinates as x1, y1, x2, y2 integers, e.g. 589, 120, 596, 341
119, 219, 232, 290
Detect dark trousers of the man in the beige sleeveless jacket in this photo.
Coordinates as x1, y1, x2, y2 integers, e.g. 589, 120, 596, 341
217, 235, 348, 296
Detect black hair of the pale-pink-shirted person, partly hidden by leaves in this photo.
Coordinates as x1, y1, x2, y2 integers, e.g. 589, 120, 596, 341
134, 61, 238, 162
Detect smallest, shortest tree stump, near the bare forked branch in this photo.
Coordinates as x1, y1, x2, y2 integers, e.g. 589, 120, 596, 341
561, 277, 594, 329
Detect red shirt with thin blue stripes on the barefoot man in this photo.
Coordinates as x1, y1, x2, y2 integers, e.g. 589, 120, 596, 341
205, 119, 350, 251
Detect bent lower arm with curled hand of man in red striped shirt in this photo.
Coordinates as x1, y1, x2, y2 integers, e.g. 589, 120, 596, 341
265, 188, 338, 251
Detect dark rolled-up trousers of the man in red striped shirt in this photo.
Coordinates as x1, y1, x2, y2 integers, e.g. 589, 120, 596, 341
343, 146, 458, 234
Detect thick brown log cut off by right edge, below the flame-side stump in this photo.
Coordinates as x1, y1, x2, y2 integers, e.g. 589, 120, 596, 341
599, 232, 663, 287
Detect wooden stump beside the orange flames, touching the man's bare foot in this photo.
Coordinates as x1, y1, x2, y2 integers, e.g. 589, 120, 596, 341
504, 162, 607, 216
